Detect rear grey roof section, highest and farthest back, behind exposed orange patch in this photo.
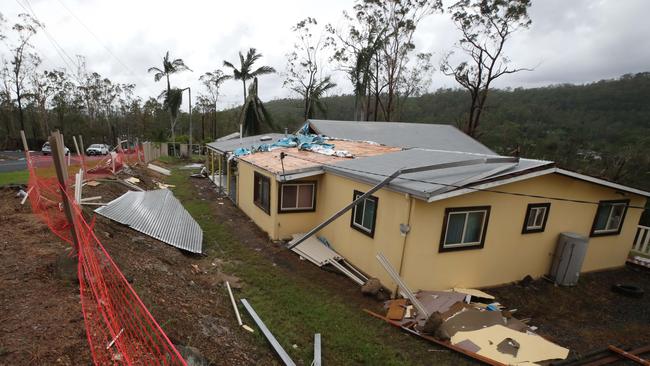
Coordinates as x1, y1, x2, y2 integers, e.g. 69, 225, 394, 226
307, 119, 495, 154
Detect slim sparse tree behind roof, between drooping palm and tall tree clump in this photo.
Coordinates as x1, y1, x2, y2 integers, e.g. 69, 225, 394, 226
283, 17, 336, 120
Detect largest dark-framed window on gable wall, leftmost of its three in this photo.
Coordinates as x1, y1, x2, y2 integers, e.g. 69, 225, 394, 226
439, 206, 490, 252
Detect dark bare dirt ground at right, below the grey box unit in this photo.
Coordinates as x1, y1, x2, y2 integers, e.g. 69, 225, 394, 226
487, 265, 650, 354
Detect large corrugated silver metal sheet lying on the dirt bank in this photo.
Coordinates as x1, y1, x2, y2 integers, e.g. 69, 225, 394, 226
95, 189, 203, 253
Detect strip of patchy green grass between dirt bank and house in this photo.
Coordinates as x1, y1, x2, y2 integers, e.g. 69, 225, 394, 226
167, 170, 469, 365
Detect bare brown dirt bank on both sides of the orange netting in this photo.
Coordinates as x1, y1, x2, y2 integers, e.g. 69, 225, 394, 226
0, 172, 277, 365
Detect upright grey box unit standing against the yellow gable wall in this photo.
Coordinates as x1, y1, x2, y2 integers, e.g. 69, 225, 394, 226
550, 233, 589, 286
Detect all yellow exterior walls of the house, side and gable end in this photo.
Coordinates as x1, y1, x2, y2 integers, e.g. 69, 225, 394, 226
238, 161, 645, 290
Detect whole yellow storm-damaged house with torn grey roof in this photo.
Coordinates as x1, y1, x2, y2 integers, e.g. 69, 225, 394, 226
208, 120, 650, 289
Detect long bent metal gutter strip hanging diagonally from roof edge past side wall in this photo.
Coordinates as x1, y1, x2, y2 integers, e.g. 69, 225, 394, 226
288, 157, 519, 249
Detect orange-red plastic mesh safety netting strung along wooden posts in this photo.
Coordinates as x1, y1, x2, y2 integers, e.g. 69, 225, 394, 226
27, 150, 186, 365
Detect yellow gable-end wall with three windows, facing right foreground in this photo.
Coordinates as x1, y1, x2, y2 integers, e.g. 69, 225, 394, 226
402, 174, 645, 289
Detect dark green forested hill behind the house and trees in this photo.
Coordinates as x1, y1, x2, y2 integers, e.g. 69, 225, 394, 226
221, 73, 650, 189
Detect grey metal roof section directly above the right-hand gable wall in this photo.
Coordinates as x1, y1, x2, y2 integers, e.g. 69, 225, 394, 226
324, 149, 554, 200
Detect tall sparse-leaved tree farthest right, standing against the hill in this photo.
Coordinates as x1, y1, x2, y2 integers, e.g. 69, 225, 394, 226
440, 0, 531, 137
